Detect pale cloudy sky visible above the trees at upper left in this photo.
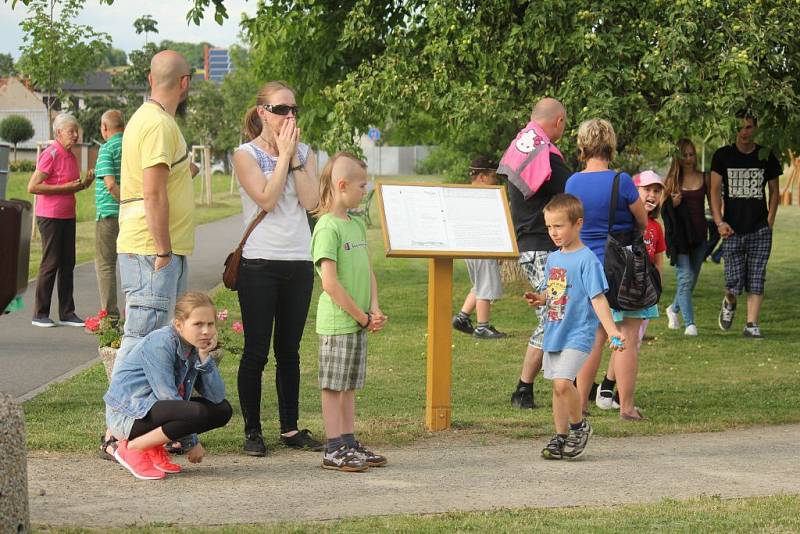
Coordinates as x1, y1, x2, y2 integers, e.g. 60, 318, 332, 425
0, 0, 257, 59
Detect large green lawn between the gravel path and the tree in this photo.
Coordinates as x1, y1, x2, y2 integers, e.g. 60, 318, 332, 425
25, 174, 800, 452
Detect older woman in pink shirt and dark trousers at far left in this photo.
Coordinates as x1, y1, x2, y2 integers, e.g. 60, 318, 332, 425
28, 113, 93, 328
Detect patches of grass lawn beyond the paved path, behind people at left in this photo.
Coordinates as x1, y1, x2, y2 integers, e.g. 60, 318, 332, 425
6, 172, 242, 278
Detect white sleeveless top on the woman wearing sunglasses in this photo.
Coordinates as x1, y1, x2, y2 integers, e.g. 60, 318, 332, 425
237, 143, 311, 261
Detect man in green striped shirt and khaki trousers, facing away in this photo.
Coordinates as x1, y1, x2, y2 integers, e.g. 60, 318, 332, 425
94, 109, 125, 321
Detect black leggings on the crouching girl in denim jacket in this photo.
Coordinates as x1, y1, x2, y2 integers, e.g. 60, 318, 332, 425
128, 397, 233, 441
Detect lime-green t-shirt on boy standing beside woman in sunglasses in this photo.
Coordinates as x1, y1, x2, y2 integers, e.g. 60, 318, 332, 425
311, 213, 370, 335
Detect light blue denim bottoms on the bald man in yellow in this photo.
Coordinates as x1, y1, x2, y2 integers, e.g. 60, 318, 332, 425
114, 254, 189, 368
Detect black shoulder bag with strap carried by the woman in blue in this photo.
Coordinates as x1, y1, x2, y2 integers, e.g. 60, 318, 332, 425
603, 173, 661, 311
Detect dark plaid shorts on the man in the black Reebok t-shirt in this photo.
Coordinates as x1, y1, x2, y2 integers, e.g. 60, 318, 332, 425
722, 226, 772, 295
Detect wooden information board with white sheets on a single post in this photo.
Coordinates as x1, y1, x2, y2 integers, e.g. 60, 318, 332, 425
377, 181, 519, 430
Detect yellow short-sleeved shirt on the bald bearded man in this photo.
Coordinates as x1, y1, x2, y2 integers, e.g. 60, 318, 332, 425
117, 102, 194, 256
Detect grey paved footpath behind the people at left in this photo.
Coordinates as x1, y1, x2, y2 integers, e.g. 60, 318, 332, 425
0, 215, 242, 400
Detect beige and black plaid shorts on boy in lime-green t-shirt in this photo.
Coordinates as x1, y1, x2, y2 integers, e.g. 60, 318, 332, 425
319, 330, 367, 391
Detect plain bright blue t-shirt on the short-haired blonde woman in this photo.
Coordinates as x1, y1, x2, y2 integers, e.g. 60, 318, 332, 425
564, 170, 639, 263
